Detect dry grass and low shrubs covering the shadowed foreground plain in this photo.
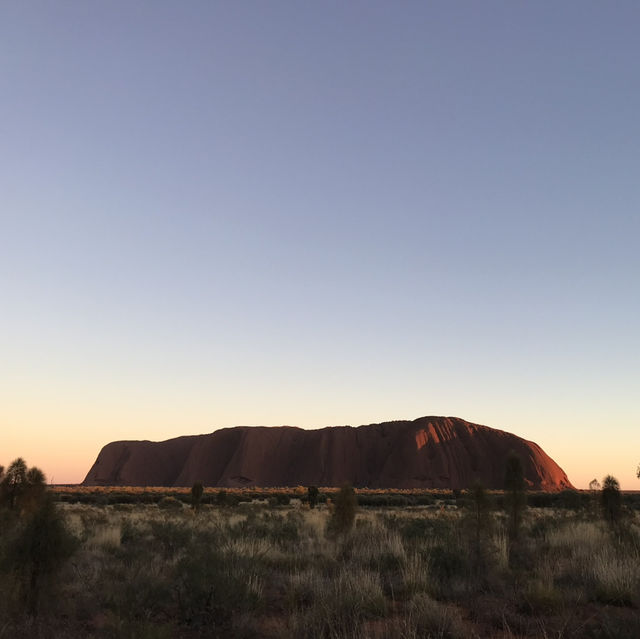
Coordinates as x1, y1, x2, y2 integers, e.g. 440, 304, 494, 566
0, 491, 640, 639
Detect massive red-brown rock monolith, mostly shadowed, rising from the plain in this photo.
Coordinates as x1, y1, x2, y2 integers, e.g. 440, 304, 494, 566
84, 417, 572, 491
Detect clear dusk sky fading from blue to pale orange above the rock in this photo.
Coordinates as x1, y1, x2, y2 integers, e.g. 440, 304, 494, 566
0, 0, 640, 490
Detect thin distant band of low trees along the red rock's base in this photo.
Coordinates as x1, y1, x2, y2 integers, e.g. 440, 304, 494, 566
51, 486, 640, 510
